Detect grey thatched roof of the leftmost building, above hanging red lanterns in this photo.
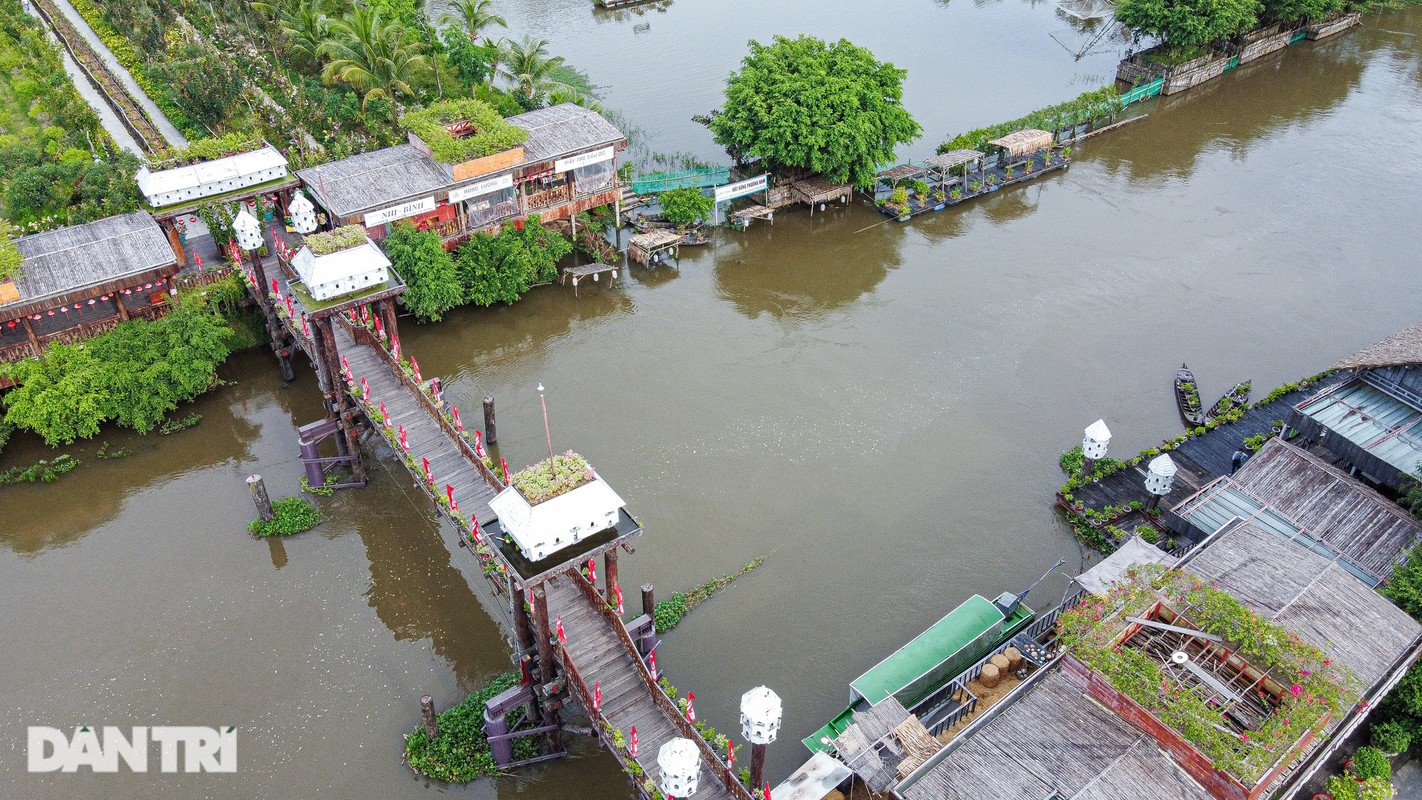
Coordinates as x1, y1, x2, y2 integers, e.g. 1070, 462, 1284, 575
0, 212, 178, 315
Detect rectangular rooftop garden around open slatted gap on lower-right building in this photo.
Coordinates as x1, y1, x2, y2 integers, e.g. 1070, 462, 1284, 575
1059, 564, 1359, 787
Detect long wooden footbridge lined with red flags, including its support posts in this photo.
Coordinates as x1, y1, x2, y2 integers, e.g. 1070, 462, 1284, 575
243, 241, 752, 800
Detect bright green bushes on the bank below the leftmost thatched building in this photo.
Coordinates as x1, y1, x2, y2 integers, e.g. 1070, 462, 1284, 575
3, 297, 232, 446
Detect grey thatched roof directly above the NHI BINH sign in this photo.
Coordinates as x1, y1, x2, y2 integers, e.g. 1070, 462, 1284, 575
296, 145, 454, 217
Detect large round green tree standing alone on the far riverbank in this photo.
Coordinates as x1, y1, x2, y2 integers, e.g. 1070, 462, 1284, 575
708, 36, 921, 186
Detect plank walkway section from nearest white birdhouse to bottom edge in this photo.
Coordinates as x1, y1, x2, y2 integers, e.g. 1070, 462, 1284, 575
545, 574, 751, 800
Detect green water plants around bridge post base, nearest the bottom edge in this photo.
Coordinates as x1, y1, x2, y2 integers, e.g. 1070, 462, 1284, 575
405, 672, 538, 783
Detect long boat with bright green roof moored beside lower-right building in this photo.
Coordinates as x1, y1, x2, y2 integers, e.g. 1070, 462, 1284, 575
802, 560, 1065, 753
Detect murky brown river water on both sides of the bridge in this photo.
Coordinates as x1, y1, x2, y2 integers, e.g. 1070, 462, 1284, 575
8, 0, 1422, 800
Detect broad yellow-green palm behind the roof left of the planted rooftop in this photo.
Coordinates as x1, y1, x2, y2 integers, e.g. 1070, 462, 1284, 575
320, 6, 429, 118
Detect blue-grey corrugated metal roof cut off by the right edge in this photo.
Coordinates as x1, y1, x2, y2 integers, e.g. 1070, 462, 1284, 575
1298, 381, 1422, 475
